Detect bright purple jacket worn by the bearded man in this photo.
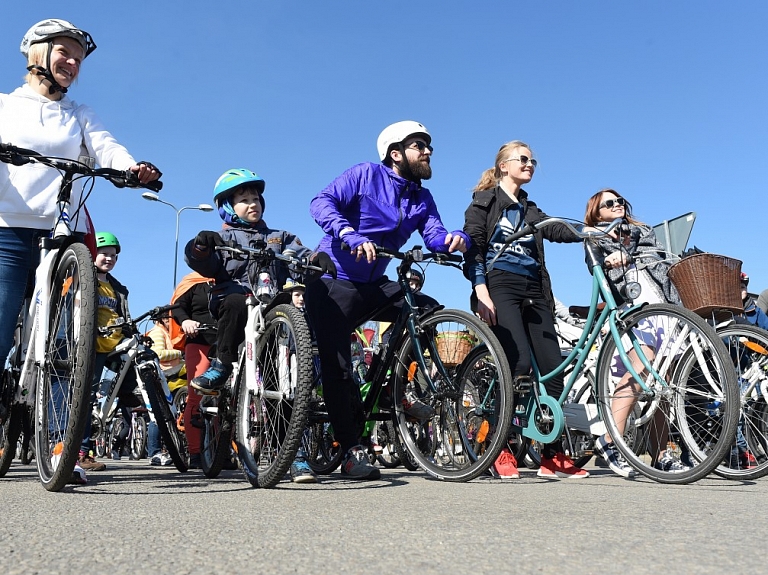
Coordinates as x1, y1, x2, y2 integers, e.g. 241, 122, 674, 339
309, 163, 470, 283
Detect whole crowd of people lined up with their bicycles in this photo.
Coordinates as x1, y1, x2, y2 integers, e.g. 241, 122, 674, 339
0, 19, 765, 484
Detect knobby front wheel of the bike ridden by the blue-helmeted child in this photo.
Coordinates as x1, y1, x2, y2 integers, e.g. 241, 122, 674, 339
235, 304, 313, 487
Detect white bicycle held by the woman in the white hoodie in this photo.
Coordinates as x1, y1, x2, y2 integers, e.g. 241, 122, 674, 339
0, 144, 162, 491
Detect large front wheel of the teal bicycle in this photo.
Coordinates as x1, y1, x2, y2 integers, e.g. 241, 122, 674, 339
597, 304, 739, 484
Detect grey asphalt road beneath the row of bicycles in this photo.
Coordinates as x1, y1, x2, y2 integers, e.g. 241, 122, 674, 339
0, 460, 768, 575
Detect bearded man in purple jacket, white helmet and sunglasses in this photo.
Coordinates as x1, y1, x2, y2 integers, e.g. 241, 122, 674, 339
305, 121, 469, 479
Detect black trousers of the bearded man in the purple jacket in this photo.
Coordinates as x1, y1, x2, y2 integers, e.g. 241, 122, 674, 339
304, 276, 437, 453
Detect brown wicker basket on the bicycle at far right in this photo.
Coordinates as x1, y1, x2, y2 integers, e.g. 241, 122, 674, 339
669, 254, 744, 317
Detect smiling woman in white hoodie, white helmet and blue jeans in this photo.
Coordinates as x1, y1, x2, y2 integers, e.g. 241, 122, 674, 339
0, 19, 161, 363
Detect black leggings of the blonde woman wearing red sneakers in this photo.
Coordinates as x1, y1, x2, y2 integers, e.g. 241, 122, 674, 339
488, 270, 563, 457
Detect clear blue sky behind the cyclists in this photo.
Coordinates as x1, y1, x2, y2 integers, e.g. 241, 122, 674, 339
0, 0, 768, 320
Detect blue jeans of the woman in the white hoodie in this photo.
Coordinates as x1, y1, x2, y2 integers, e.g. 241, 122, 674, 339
0, 228, 48, 366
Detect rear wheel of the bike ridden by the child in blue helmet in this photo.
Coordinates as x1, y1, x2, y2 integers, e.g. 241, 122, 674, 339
199, 392, 231, 479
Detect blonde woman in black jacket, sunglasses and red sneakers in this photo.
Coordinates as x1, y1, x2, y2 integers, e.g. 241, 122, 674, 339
464, 140, 589, 479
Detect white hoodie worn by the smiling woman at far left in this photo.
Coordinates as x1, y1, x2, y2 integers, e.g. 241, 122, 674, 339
0, 84, 136, 231
